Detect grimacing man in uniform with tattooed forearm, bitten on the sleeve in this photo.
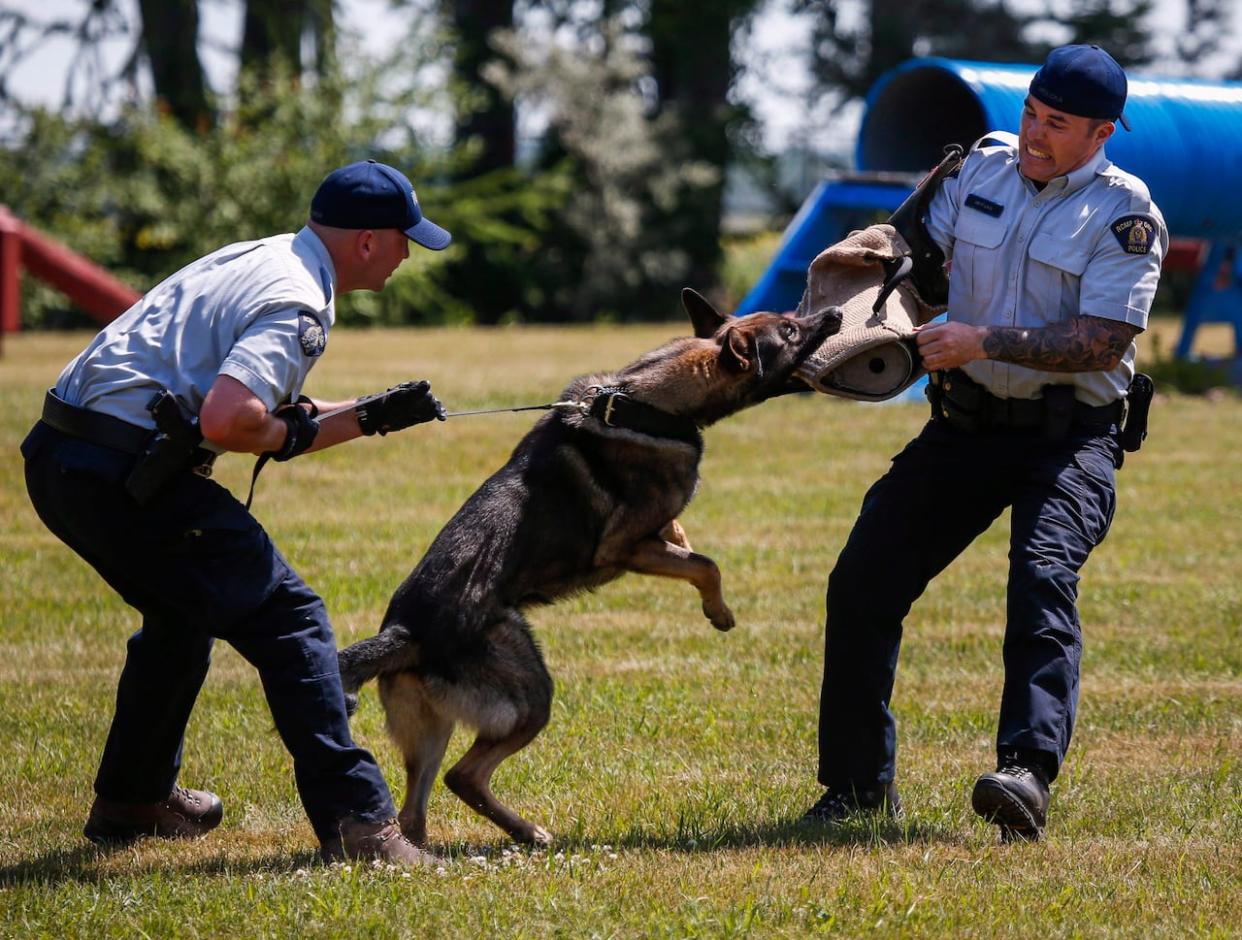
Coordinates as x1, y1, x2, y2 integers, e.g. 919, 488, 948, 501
806, 45, 1167, 838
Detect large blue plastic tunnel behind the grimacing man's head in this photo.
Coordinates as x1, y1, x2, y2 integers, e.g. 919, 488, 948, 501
857, 58, 1242, 238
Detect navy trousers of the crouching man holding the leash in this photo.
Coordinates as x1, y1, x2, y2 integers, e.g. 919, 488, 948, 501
21, 422, 395, 841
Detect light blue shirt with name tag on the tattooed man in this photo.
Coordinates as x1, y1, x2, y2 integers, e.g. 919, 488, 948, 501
928, 133, 1169, 405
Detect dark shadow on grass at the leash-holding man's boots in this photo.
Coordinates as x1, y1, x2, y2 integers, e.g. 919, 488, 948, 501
0, 843, 319, 888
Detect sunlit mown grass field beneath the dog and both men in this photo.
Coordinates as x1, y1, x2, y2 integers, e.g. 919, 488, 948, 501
0, 324, 1242, 938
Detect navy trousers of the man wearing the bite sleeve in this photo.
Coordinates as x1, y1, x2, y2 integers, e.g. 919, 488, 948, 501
818, 420, 1120, 791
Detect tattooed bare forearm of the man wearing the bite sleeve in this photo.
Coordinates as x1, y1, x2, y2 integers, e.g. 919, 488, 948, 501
984, 317, 1139, 373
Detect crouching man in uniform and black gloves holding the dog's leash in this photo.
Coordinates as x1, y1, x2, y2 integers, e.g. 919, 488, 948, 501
21, 160, 450, 864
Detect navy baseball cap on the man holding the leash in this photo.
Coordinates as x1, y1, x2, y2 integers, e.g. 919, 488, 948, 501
311, 160, 453, 251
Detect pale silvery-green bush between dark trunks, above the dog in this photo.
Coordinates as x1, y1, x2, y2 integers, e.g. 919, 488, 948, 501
488, 22, 720, 320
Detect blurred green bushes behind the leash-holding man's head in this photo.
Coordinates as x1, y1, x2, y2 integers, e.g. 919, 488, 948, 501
0, 54, 564, 327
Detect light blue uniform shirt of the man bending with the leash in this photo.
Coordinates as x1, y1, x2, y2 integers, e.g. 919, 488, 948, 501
56, 228, 337, 437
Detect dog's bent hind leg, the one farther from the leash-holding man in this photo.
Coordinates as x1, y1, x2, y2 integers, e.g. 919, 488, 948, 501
445, 613, 553, 846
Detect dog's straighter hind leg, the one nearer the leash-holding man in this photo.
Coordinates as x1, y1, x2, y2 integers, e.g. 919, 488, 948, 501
380, 672, 453, 846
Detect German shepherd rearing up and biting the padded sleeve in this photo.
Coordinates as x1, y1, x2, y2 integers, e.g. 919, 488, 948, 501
340, 289, 841, 846
